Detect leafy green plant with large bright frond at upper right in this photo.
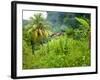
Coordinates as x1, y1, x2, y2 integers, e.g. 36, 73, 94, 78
66, 17, 90, 40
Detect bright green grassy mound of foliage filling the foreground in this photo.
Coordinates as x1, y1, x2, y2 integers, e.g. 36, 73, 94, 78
24, 36, 90, 69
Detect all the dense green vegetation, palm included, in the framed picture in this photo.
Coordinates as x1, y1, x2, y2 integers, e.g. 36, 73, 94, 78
23, 13, 91, 69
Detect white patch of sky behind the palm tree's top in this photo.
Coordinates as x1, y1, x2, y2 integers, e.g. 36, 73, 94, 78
23, 11, 47, 20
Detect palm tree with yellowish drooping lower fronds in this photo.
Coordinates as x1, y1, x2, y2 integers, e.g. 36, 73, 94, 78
28, 13, 49, 53
